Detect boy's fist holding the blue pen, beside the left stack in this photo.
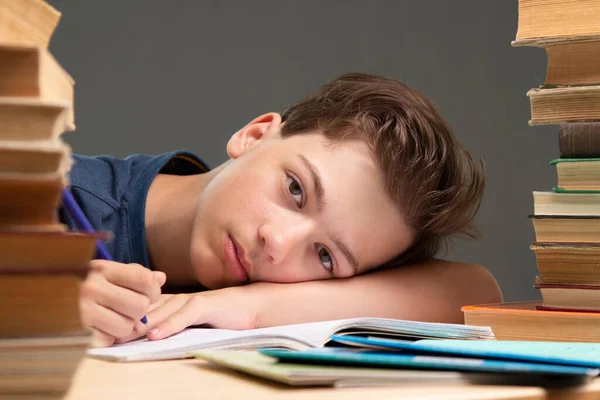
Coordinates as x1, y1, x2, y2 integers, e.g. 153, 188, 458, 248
80, 260, 167, 346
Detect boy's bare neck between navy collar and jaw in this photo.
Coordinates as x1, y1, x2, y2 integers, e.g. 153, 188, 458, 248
145, 171, 213, 286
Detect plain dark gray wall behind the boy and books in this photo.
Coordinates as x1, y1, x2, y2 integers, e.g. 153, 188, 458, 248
50, 0, 558, 301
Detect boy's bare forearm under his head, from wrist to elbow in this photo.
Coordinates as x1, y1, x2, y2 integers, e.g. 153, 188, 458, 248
240, 260, 502, 327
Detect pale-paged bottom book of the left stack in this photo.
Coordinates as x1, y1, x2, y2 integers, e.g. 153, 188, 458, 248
0, 333, 91, 399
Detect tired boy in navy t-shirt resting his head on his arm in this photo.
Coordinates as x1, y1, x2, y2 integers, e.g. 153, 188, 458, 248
61, 74, 501, 345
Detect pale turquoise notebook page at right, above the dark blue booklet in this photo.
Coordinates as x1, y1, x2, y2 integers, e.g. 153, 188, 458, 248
417, 340, 600, 367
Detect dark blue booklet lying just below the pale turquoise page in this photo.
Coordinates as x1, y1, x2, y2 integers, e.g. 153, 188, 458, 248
259, 347, 599, 381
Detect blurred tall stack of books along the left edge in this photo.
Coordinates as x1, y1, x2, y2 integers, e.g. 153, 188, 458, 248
0, 0, 96, 398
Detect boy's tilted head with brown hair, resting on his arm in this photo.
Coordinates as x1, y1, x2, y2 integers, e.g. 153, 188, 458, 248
191, 74, 484, 288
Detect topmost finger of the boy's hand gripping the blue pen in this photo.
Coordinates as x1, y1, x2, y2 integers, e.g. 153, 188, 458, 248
102, 262, 166, 303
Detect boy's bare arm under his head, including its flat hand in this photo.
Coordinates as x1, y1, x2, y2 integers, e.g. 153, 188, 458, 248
131, 260, 502, 341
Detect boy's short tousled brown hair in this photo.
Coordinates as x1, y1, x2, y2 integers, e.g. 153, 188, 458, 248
281, 73, 485, 267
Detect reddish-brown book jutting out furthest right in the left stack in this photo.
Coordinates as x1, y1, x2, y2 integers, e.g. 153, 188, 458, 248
0, 230, 97, 268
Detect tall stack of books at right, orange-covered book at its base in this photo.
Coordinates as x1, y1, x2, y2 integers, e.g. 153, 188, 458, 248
463, 0, 600, 342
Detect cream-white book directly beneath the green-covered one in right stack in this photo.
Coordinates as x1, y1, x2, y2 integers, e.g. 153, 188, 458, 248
533, 191, 600, 216
